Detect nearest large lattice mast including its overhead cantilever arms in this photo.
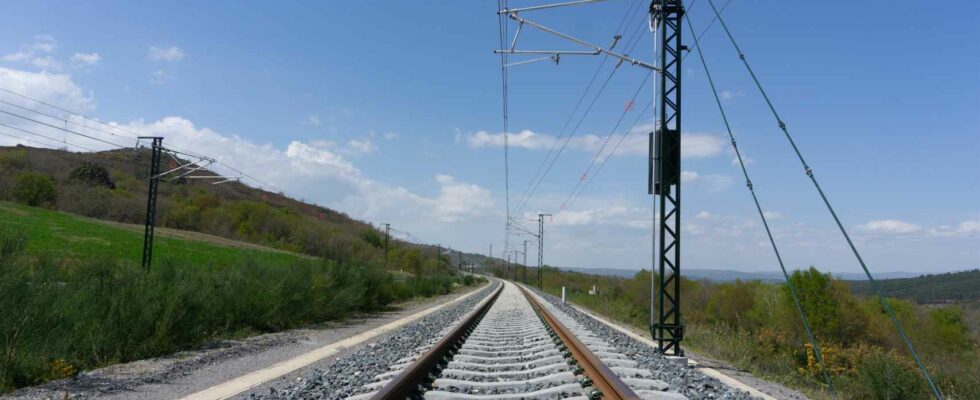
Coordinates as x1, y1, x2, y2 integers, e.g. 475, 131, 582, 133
494, 0, 687, 356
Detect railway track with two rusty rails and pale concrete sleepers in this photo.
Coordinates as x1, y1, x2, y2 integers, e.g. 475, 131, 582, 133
351, 282, 686, 400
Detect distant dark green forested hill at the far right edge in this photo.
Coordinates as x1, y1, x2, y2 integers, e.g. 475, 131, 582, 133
849, 269, 980, 304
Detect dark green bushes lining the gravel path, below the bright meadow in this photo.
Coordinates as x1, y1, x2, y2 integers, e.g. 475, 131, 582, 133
0, 245, 474, 392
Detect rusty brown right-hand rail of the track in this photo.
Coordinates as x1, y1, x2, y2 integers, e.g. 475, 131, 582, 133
517, 285, 640, 400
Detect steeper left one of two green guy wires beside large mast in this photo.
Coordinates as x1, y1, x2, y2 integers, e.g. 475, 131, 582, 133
684, 7, 837, 399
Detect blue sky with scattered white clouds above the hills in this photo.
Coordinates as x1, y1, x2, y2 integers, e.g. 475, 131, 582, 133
0, 0, 980, 272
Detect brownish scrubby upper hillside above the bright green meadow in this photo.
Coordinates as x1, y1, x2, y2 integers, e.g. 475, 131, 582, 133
0, 146, 447, 274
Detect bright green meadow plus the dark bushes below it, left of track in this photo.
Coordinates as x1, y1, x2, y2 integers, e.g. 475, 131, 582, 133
0, 203, 477, 393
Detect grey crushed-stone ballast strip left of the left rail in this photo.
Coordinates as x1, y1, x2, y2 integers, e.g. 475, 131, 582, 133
250, 283, 499, 399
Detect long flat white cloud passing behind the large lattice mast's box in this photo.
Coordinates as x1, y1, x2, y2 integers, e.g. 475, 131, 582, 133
456, 128, 727, 158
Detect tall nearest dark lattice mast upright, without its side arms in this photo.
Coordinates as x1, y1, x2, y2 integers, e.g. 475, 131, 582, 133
647, 0, 687, 356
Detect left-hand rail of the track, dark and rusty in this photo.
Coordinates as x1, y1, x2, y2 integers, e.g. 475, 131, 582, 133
371, 282, 504, 400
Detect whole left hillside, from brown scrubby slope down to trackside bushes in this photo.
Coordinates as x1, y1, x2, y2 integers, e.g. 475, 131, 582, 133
0, 148, 474, 393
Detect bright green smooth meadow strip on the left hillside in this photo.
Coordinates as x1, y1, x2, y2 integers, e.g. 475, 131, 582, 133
0, 202, 305, 266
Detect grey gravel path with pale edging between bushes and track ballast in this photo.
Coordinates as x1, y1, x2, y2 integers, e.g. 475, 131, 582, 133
0, 285, 483, 400
